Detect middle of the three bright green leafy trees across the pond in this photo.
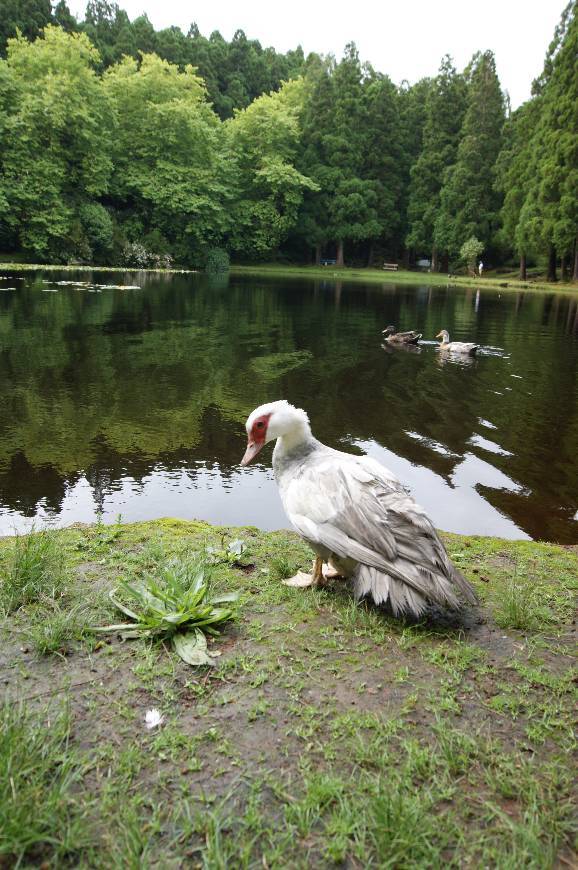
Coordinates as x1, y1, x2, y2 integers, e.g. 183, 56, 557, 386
103, 54, 231, 263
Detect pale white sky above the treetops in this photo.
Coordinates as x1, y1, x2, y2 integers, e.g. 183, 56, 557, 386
69, 0, 565, 108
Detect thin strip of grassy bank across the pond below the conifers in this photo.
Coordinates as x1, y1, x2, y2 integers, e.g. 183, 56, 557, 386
231, 264, 578, 293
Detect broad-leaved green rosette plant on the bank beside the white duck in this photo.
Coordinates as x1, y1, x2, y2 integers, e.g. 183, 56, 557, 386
94, 558, 238, 665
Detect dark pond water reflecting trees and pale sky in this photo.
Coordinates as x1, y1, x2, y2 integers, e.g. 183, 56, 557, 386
0, 272, 578, 543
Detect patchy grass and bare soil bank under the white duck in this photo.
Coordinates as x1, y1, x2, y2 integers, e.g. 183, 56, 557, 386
0, 520, 578, 870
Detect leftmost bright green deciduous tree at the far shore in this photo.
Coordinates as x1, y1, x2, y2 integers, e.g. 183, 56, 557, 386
0, 26, 115, 262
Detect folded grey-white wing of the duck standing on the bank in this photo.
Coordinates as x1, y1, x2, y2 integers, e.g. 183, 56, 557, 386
283, 453, 475, 601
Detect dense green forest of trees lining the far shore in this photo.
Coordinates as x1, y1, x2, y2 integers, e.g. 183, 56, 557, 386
0, 0, 578, 280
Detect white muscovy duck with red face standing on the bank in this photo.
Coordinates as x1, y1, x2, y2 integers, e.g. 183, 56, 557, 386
241, 399, 477, 616
